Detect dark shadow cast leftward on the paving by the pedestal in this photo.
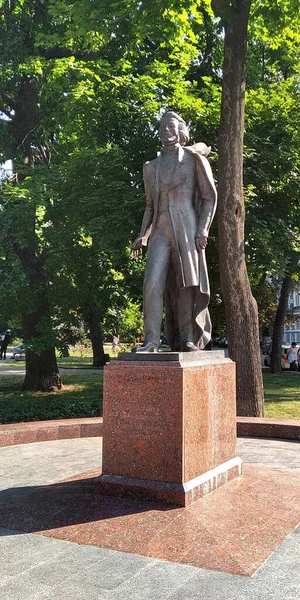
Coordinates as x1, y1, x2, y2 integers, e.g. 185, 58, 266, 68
0, 477, 176, 534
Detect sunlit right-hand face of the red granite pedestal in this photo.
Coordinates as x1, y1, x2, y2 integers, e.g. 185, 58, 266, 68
183, 361, 236, 481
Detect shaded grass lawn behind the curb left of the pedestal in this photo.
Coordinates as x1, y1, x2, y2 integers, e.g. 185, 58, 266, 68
0, 371, 102, 423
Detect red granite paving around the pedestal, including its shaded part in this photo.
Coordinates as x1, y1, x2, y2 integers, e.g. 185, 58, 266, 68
0, 465, 300, 576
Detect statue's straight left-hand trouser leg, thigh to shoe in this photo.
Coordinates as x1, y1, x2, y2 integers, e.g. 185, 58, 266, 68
144, 232, 172, 347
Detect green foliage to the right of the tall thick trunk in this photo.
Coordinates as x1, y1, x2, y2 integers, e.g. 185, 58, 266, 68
245, 0, 300, 278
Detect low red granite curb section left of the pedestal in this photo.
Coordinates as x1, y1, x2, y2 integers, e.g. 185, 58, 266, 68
0, 417, 103, 447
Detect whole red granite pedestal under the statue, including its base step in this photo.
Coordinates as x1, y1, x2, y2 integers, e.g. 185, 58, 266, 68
97, 351, 241, 506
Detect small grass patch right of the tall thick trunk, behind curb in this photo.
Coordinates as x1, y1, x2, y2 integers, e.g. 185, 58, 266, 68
263, 371, 300, 419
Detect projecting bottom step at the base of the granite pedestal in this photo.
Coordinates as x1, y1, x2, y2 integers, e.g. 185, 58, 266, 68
96, 456, 242, 506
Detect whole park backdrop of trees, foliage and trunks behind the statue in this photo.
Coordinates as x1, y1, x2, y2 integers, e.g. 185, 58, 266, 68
0, 0, 300, 419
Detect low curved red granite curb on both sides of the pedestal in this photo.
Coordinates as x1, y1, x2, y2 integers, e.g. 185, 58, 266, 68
0, 417, 300, 447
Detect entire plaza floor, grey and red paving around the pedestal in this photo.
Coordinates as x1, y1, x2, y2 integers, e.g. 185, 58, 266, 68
0, 438, 300, 600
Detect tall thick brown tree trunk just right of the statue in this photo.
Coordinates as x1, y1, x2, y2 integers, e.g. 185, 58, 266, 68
213, 0, 263, 417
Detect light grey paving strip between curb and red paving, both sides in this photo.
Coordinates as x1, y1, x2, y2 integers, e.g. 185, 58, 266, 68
0, 438, 300, 493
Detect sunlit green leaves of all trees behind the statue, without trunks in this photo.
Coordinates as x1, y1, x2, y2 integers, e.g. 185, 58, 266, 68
0, 0, 300, 360
